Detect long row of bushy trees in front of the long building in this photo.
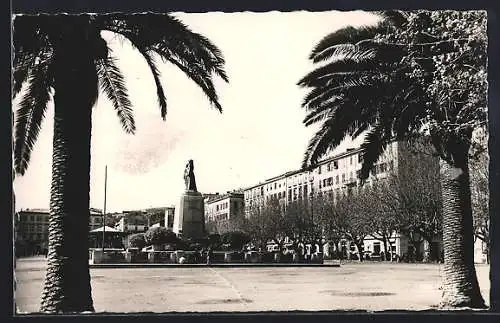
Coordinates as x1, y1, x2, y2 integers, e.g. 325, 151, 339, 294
207, 143, 489, 261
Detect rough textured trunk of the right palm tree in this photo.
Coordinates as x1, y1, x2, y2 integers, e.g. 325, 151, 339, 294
441, 161, 485, 308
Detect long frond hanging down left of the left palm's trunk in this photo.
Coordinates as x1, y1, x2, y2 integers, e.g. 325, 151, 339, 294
14, 65, 51, 175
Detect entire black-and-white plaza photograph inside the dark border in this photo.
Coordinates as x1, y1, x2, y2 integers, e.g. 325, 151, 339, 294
9, 10, 491, 316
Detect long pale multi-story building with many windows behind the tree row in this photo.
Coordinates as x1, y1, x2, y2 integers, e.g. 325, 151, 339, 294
243, 141, 441, 260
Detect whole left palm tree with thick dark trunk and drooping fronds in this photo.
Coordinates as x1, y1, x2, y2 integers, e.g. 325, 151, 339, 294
13, 14, 227, 312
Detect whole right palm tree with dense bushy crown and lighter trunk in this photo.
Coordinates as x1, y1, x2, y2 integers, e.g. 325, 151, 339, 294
298, 11, 487, 308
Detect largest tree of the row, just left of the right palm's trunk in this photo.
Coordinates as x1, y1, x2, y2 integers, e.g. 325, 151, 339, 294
374, 142, 442, 261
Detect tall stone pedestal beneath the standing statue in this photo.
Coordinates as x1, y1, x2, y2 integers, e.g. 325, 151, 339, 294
173, 191, 205, 239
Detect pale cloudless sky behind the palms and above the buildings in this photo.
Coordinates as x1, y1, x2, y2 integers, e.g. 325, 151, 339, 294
14, 11, 376, 212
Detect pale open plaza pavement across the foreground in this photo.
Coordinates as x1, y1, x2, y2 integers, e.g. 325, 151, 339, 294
15, 257, 490, 313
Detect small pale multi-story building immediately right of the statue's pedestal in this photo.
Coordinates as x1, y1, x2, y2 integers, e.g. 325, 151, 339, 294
205, 192, 244, 222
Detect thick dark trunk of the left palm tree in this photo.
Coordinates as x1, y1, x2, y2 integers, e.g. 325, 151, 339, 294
40, 24, 97, 313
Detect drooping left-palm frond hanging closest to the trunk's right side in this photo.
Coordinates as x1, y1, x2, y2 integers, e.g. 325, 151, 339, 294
97, 57, 135, 133
